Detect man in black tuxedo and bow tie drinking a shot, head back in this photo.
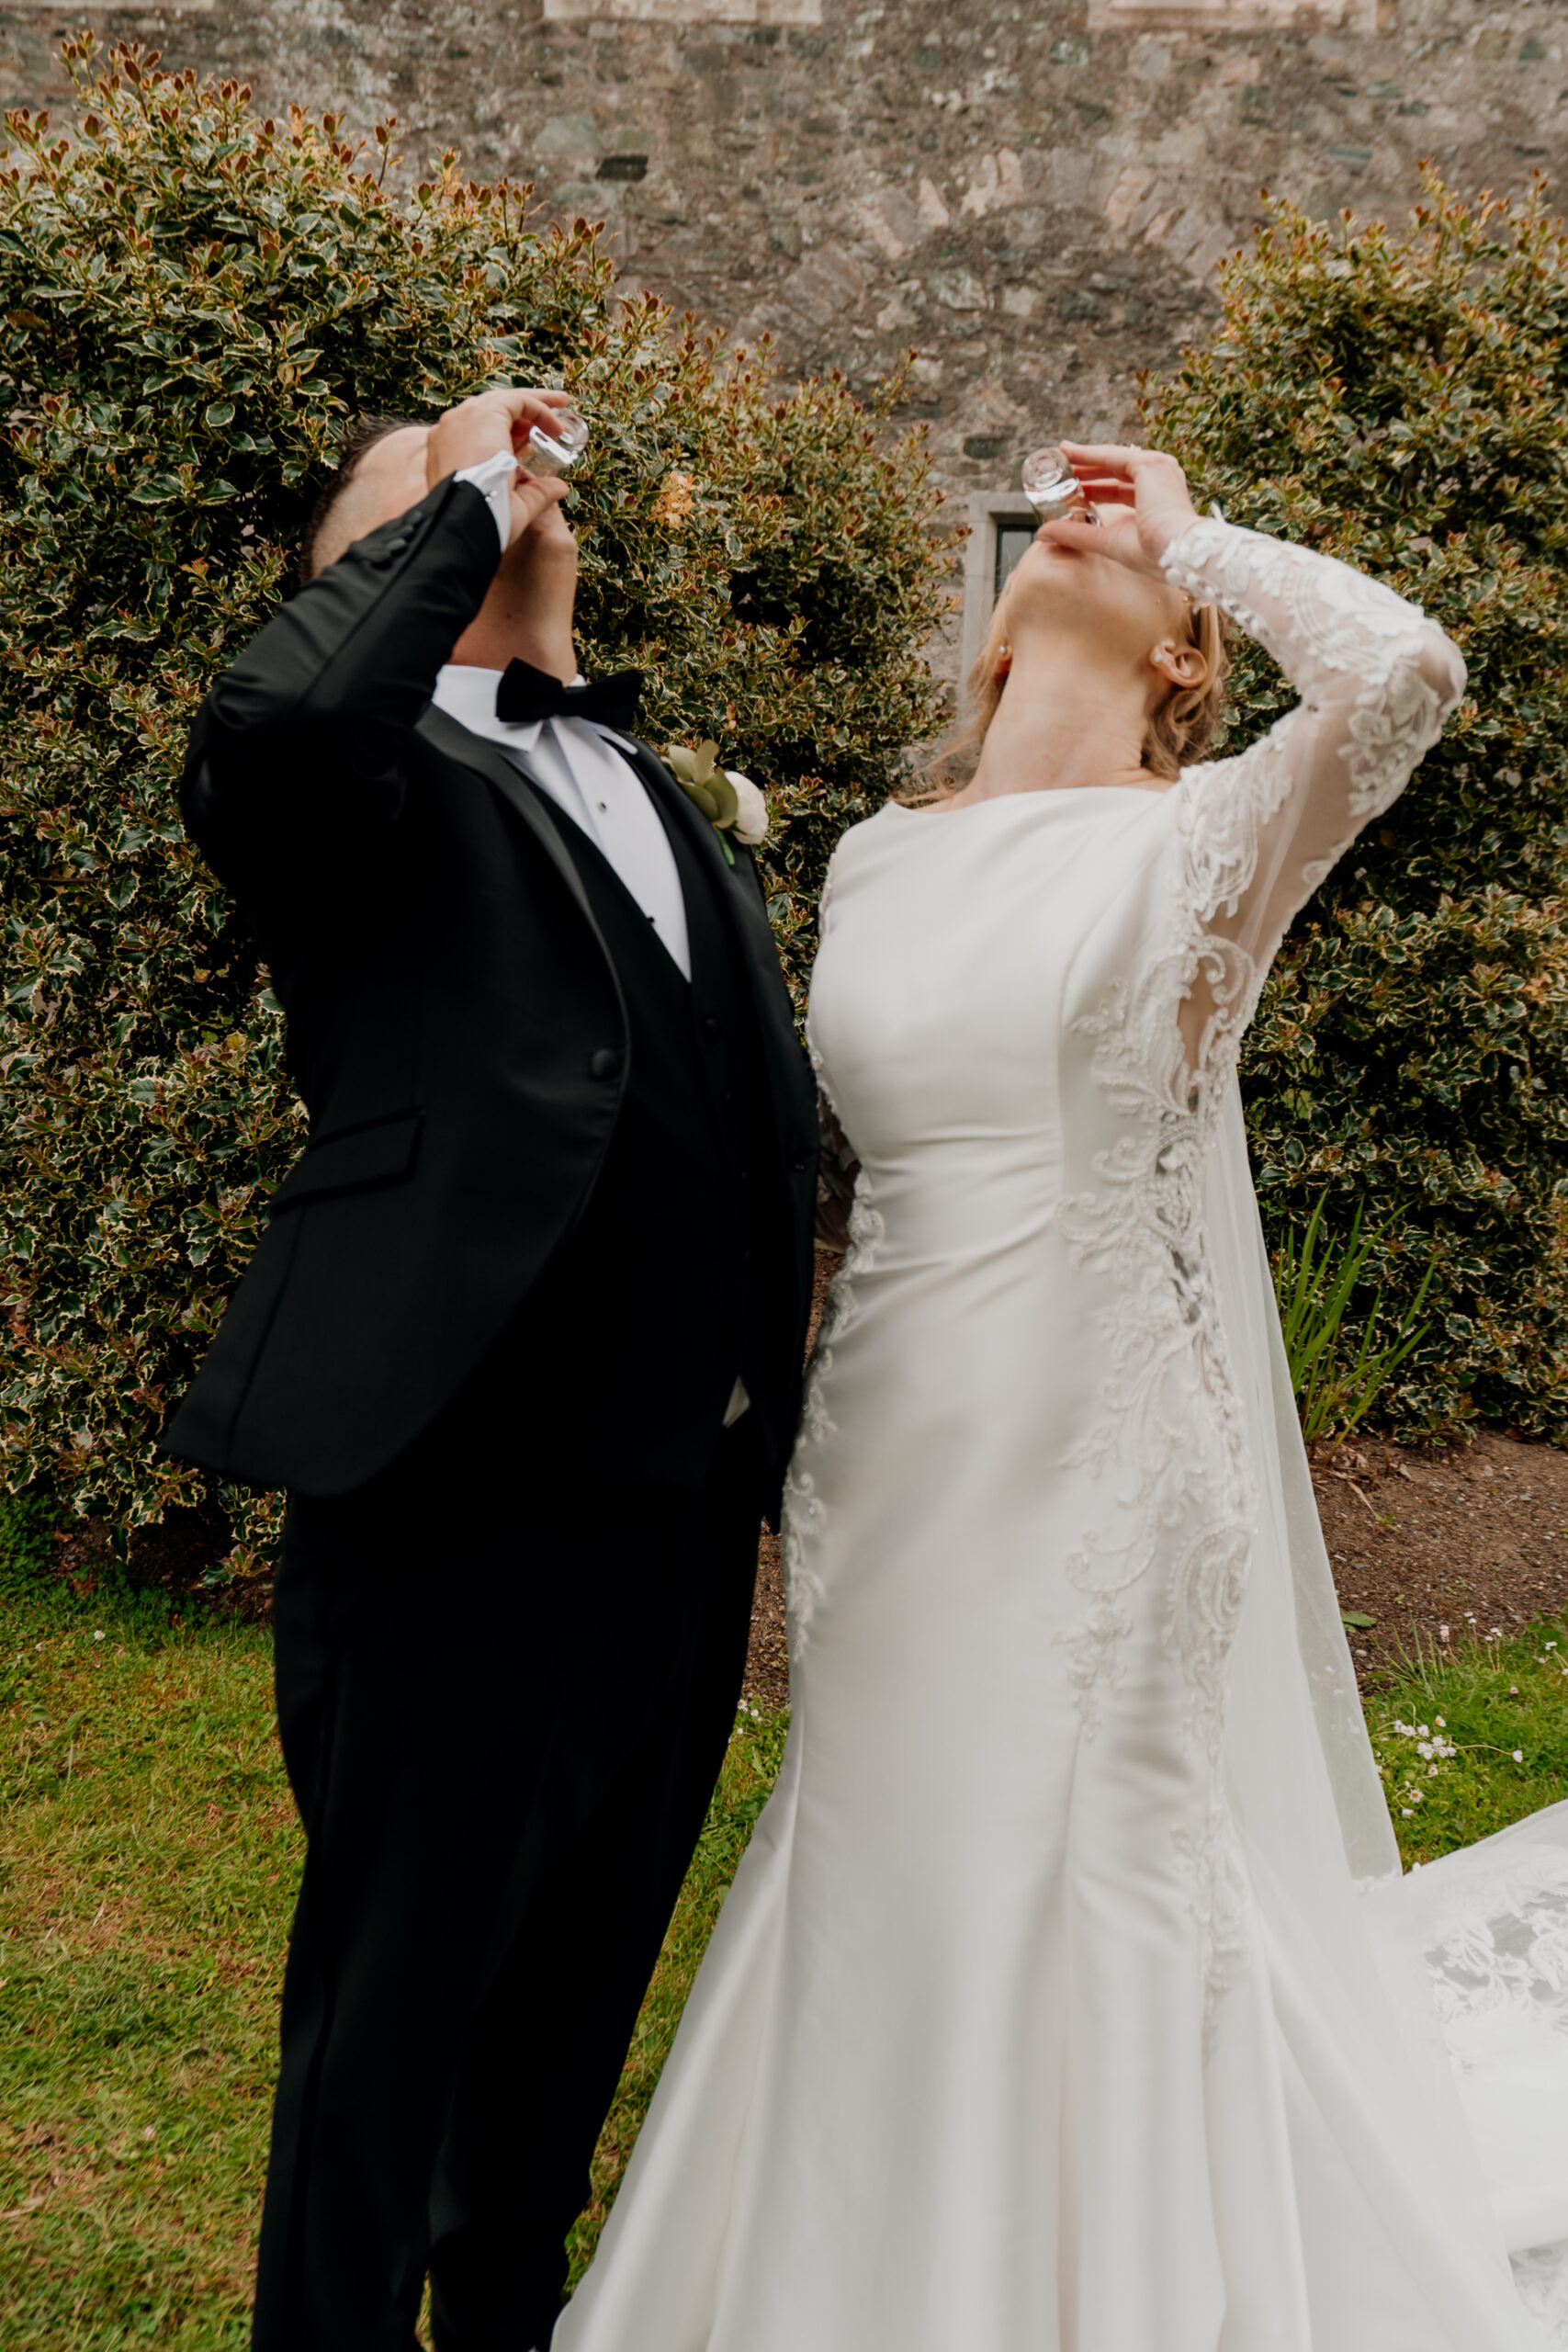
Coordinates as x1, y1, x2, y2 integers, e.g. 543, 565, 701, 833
167, 393, 816, 2352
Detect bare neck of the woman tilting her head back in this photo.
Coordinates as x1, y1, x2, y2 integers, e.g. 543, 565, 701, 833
947, 639, 1161, 807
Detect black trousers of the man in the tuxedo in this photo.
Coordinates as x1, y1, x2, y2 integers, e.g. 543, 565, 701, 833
254, 1416, 764, 2352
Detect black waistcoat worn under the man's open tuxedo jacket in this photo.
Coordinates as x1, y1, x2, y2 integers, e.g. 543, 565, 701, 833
413, 795, 792, 1487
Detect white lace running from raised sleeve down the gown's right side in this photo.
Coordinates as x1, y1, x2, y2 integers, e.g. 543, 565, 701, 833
1060, 522, 1462, 2007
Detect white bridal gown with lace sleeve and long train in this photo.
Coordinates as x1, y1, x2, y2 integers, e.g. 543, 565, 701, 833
555, 522, 1568, 2352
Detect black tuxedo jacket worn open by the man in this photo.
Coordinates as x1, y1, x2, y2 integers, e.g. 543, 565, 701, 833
164, 480, 818, 1496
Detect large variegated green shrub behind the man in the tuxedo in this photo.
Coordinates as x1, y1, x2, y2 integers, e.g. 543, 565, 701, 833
0, 38, 945, 1529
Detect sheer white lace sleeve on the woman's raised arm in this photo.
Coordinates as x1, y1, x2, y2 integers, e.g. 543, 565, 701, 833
1164, 522, 1464, 1066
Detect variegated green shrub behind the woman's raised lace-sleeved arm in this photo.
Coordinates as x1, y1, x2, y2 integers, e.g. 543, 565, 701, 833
1147, 181, 1568, 1435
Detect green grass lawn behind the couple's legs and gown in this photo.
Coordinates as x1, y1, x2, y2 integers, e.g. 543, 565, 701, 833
0, 1476, 1568, 2352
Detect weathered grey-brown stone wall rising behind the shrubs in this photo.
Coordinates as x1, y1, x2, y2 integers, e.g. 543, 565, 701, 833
0, 0, 1568, 662
